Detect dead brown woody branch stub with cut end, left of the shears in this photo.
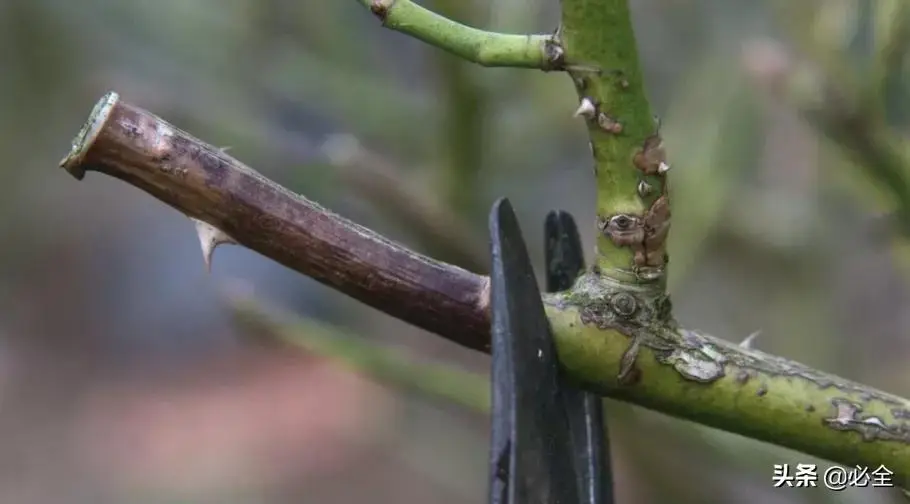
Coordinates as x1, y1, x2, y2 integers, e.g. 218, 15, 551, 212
61, 92, 490, 351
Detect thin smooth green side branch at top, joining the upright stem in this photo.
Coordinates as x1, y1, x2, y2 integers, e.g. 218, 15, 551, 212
358, 0, 562, 70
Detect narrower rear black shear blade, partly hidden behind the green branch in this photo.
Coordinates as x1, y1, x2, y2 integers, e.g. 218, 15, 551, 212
544, 210, 613, 504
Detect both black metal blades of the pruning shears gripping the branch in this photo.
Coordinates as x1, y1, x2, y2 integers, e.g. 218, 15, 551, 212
490, 199, 612, 504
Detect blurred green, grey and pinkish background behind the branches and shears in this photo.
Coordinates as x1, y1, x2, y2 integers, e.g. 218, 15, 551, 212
0, 0, 910, 504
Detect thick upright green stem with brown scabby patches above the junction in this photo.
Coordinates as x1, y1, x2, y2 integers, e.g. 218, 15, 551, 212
559, 0, 669, 286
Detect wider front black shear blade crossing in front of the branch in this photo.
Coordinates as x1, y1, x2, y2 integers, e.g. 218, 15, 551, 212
490, 199, 579, 504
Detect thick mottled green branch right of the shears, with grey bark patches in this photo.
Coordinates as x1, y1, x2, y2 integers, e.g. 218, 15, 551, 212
545, 275, 910, 487
